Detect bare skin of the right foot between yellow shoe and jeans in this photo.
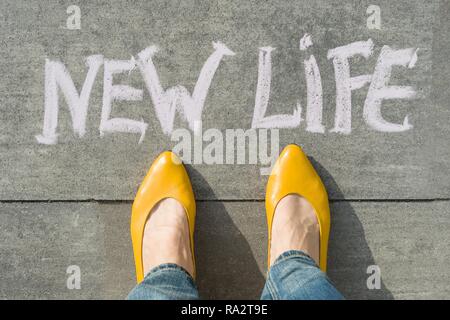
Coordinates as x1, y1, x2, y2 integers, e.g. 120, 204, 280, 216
270, 195, 320, 265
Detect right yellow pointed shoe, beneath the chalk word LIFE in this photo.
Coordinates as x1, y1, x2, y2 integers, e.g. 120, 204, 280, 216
266, 145, 330, 272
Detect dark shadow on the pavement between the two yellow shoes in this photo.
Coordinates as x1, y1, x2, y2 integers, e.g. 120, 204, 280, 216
186, 165, 266, 299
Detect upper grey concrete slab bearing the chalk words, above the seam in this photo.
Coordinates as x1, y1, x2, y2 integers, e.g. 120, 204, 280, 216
0, 0, 450, 200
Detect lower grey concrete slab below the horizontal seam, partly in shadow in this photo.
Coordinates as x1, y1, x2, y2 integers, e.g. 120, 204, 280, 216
0, 201, 450, 299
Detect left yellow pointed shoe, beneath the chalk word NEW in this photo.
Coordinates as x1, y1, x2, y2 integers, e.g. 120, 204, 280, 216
131, 151, 195, 283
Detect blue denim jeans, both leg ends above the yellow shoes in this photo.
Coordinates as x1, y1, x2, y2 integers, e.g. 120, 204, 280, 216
127, 250, 344, 300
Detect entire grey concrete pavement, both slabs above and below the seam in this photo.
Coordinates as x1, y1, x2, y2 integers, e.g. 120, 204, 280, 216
0, 0, 450, 299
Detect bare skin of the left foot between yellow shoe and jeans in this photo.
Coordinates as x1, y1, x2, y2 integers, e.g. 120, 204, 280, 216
142, 198, 194, 276
